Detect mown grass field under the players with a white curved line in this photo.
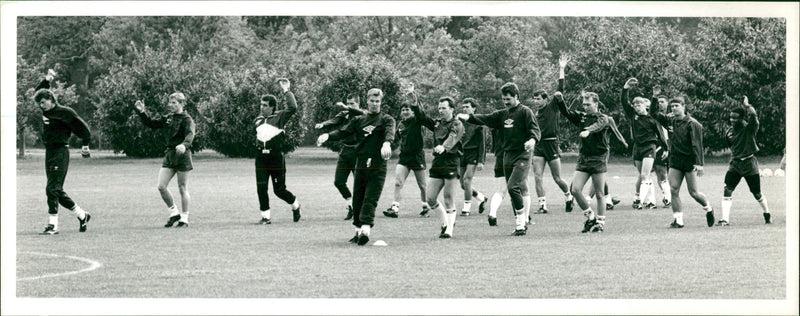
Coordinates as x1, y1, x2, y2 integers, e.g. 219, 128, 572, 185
9, 148, 793, 300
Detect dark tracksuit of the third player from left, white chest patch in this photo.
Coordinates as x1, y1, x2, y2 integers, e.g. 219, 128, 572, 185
253, 92, 297, 211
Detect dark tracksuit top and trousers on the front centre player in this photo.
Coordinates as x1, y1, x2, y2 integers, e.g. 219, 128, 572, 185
328, 113, 395, 227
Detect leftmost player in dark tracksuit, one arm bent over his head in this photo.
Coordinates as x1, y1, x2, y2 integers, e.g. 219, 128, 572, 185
34, 70, 92, 235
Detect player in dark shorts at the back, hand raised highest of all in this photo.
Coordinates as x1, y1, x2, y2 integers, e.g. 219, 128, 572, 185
533, 55, 572, 214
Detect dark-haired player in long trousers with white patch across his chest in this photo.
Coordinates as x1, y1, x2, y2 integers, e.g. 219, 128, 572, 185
253, 80, 300, 225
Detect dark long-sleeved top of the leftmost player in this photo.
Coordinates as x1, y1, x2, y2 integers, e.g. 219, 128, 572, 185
36, 80, 92, 148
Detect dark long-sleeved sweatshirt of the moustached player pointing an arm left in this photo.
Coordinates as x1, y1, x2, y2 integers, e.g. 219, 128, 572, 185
467, 103, 541, 152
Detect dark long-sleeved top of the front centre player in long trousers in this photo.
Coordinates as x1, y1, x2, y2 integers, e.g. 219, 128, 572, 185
328, 113, 395, 162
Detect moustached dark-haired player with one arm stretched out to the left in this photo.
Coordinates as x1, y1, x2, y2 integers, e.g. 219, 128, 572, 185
459, 83, 540, 236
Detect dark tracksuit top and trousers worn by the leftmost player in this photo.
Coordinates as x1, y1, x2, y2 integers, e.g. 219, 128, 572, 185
36, 80, 92, 214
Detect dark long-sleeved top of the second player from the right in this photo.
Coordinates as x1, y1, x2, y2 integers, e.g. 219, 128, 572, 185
650, 102, 703, 166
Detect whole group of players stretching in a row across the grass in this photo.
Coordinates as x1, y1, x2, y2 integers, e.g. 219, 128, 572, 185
29, 57, 772, 245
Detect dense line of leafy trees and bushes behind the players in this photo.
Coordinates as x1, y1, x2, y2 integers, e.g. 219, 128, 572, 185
17, 16, 786, 157
